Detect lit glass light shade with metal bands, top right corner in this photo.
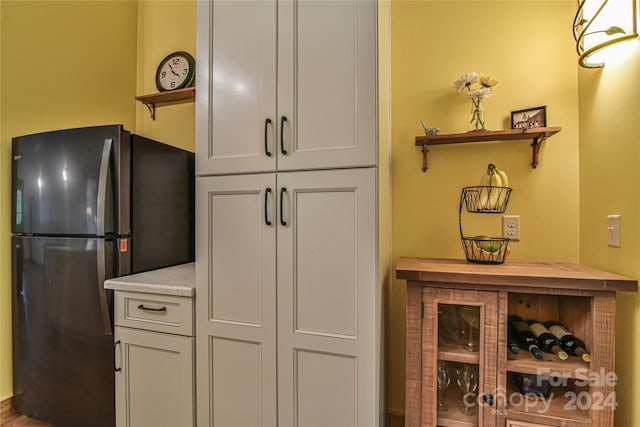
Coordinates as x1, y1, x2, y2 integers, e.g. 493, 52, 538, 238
573, 0, 638, 68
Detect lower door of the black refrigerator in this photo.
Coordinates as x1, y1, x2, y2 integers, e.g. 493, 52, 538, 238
12, 236, 118, 427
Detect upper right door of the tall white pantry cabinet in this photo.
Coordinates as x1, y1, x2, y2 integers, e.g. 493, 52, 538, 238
278, 0, 377, 170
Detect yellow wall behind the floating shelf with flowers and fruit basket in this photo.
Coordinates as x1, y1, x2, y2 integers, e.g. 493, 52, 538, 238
387, 1, 580, 412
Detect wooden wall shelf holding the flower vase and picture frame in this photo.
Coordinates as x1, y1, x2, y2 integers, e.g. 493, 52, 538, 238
416, 126, 562, 172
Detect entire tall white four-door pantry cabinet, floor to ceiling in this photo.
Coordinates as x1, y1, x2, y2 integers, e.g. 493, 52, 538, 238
196, 0, 386, 427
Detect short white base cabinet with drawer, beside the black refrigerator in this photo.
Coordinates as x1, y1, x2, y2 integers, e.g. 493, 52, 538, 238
114, 291, 195, 427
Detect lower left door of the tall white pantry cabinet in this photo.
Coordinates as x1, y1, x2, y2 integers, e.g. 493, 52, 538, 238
196, 174, 277, 427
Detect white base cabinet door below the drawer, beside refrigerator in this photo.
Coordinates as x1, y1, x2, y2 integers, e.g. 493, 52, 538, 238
114, 326, 195, 427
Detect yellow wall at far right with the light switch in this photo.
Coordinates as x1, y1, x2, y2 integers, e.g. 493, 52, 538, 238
579, 40, 640, 426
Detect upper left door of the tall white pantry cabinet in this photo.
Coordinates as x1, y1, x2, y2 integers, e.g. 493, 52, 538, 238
196, 0, 277, 175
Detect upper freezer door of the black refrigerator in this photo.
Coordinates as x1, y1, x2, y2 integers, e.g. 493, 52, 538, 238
12, 125, 129, 236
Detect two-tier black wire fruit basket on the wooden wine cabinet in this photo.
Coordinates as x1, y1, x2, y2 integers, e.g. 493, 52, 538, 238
458, 186, 511, 264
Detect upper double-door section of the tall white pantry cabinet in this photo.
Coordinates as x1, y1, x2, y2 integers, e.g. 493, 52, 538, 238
196, 0, 377, 175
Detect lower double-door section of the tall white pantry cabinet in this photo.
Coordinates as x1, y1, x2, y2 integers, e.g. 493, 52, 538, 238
196, 168, 379, 426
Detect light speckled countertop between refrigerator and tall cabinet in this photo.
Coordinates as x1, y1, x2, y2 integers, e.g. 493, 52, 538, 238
104, 262, 196, 297
